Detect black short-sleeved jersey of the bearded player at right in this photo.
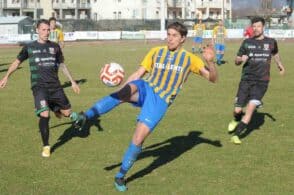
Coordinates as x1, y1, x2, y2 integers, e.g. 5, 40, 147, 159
237, 37, 278, 81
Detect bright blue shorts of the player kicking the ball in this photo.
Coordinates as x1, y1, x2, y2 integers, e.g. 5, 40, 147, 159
130, 80, 168, 131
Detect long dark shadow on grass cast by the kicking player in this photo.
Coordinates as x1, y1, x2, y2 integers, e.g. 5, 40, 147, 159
104, 131, 222, 182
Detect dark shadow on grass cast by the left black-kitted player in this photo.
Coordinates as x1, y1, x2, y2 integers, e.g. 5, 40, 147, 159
50, 119, 103, 153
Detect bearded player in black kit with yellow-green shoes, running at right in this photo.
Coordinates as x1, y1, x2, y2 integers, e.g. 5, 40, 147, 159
228, 17, 285, 144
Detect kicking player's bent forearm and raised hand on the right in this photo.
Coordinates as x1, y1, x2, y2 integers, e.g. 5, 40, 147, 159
200, 46, 218, 83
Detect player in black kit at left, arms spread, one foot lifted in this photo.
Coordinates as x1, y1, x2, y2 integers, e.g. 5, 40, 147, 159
0, 19, 80, 157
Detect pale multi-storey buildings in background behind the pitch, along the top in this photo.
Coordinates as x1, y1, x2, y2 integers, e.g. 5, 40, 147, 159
0, 0, 232, 20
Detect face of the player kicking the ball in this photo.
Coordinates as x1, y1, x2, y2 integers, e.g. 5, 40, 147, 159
167, 28, 186, 51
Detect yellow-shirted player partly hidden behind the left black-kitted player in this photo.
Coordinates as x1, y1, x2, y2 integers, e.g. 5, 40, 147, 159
49, 17, 64, 48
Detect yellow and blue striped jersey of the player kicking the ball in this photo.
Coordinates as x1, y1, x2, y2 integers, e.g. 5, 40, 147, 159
141, 46, 204, 104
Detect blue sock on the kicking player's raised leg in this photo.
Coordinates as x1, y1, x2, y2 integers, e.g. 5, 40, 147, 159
85, 95, 120, 119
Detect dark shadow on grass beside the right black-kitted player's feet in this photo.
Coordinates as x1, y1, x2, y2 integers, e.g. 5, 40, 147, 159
240, 111, 276, 138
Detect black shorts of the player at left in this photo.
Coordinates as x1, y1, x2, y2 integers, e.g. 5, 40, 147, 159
33, 87, 71, 115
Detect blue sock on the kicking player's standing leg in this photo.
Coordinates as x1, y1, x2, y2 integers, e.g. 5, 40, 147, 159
115, 143, 142, 178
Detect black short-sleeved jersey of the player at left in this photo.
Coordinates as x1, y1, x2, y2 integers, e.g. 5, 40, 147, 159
17, 41, 64, 88
